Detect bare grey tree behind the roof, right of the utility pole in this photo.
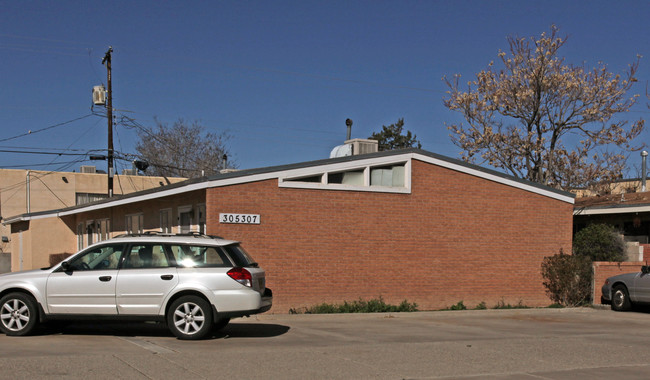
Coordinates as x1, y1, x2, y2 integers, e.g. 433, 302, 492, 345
135, 119, 232, 178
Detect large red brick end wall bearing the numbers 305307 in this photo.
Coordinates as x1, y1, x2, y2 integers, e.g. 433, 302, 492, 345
206, 160, 573, 313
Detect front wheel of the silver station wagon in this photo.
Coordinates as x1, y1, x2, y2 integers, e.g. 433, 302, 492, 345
0, 293, 38, 336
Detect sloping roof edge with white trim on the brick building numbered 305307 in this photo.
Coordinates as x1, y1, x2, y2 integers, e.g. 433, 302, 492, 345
3, 148, 575, 224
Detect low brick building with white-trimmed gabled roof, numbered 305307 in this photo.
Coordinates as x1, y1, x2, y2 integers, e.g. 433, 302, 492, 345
6, 149, 573, 313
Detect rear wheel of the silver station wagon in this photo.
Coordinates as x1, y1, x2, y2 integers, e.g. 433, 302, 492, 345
167, 296, 212, 340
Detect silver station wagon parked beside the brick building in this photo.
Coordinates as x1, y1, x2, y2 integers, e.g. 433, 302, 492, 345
0, 233, 273, 339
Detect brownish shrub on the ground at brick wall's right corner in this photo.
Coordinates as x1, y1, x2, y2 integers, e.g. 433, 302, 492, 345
542, 250, 593, 306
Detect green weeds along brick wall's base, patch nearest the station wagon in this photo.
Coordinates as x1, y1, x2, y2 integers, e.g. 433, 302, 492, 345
289, 297, 418, 314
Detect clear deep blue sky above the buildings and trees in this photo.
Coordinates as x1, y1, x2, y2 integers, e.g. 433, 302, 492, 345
0, 0, 650, 175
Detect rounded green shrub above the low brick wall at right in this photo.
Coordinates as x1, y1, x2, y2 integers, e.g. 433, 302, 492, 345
573, 224, 625, 262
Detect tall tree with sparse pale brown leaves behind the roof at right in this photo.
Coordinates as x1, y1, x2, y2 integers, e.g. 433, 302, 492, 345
444, 26, 644, 190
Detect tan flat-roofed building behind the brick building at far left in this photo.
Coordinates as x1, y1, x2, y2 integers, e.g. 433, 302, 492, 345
0, 166, 185, 273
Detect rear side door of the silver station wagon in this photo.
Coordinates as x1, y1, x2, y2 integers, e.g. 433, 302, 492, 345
116, 243, 178, 315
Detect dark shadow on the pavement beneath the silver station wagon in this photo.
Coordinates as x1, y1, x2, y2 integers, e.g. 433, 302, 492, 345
34, 321, 289, 339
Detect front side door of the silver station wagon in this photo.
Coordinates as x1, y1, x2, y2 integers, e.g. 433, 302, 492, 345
45, 244, 124, 315
